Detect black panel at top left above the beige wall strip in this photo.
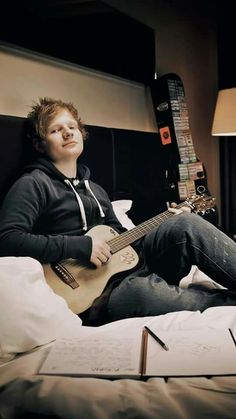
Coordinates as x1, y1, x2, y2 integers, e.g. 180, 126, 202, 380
0, 0, 155, 84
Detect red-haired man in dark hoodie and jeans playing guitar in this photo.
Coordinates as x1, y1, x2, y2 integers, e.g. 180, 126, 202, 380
0, 98, 236, 325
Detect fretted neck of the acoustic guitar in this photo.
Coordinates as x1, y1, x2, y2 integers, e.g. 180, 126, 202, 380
108, 201, 191, 254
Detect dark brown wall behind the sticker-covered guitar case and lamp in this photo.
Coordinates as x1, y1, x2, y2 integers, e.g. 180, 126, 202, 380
106, 0, 221, 217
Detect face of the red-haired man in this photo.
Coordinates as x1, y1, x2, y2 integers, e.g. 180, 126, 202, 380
42, 109, 83, 163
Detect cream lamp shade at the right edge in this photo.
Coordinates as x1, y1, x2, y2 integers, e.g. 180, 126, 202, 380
212, 87, 236, 137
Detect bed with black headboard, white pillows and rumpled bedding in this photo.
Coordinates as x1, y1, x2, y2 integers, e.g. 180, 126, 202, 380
0, 115, 236, 419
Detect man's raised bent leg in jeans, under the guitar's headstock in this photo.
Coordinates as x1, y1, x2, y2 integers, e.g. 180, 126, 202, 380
144, 213, 236, 290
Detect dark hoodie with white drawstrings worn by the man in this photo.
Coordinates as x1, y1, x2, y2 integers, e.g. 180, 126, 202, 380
0, 158, 124, 263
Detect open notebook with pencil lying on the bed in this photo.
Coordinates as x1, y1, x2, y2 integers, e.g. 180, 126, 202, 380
38, 326, 236, 378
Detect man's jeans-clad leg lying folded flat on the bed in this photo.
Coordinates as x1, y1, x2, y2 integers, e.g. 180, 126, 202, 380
106, 274, 236, 321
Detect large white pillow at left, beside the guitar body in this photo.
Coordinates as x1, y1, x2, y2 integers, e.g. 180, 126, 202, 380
0, 257, 81, 359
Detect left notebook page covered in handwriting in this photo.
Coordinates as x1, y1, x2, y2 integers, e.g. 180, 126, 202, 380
39, 329, 141, 376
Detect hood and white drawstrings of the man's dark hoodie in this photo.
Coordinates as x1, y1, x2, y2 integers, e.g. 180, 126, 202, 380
24, 157, 105, 231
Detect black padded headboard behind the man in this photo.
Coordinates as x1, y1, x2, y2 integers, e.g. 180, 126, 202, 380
0, 115, 178, 223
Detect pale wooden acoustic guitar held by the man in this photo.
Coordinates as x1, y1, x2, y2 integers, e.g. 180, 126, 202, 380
43, 195, 215, 314
